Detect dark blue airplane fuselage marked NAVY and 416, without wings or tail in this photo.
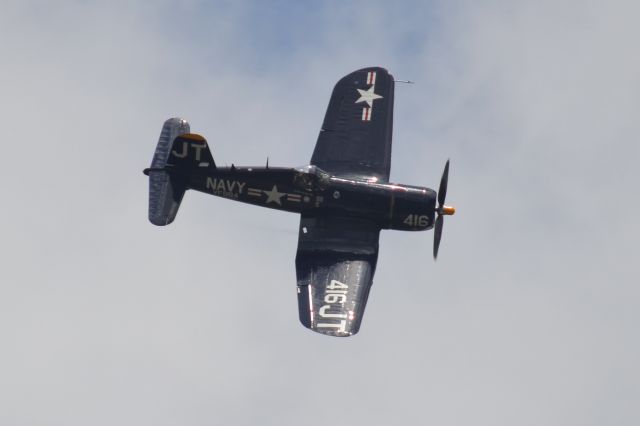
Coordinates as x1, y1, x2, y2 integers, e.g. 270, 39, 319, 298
183, 166, 436, 231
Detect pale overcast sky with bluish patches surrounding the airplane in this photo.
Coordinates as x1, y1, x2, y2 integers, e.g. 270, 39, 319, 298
0, 0, 640, 426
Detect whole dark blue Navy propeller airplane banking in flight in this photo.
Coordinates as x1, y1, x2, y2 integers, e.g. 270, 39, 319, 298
144, 67, 455, 336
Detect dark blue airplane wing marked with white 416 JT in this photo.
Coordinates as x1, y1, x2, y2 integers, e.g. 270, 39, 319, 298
296, 216, 380, 337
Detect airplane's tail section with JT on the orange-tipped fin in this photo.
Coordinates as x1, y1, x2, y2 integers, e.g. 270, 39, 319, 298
144, 118, 215, 226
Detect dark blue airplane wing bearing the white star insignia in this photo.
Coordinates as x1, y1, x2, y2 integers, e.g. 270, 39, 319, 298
311, 67, 394, 182
